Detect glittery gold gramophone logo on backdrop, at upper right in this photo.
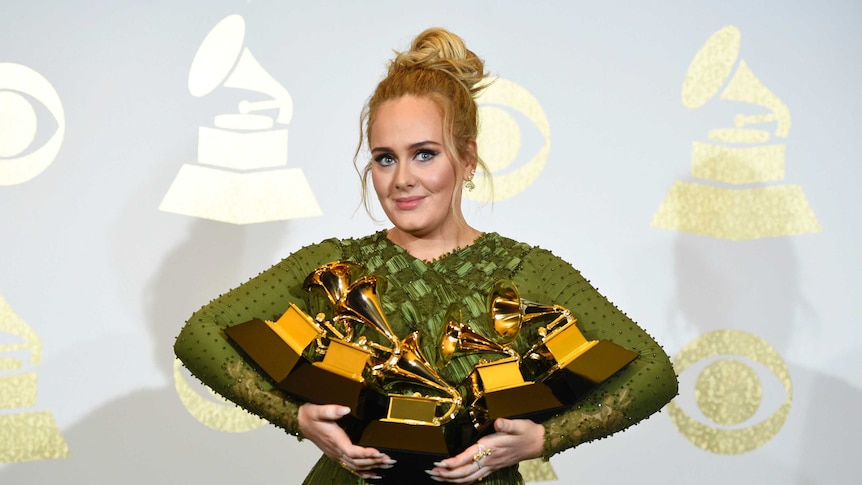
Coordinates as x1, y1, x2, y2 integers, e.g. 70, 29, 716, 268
651, 26, 820, 240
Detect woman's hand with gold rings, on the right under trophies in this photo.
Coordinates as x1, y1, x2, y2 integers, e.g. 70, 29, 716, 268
427, 418, 545, 483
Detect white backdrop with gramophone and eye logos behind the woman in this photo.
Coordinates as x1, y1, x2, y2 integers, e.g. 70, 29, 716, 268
0, 0, 862, 485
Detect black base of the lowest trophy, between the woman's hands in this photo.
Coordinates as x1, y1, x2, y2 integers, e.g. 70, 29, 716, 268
359, 420, 449, 485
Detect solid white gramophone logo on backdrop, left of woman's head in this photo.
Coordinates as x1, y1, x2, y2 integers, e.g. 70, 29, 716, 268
159, 15, 321, 224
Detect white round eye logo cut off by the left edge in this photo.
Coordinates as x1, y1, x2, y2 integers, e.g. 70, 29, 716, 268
0, 62, 66, 185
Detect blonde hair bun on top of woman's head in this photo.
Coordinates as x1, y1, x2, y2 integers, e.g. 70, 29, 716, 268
389, 27, 487, 96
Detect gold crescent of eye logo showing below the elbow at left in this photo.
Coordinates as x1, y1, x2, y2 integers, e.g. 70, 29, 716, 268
174, 359, 266, 433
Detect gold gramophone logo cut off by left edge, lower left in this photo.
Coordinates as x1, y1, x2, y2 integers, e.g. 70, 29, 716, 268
0, 296, 69, 463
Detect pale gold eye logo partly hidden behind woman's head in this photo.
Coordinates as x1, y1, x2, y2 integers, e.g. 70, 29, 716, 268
464, 78, 551, 202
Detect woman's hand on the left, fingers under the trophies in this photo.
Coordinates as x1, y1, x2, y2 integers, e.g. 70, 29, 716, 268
298, 403, 395, 478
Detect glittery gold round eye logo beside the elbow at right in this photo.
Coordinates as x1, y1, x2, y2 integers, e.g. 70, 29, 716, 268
668, 330, 793, 455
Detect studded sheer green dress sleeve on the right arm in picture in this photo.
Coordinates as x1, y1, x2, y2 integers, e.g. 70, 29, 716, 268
514, 249, 677, 460
